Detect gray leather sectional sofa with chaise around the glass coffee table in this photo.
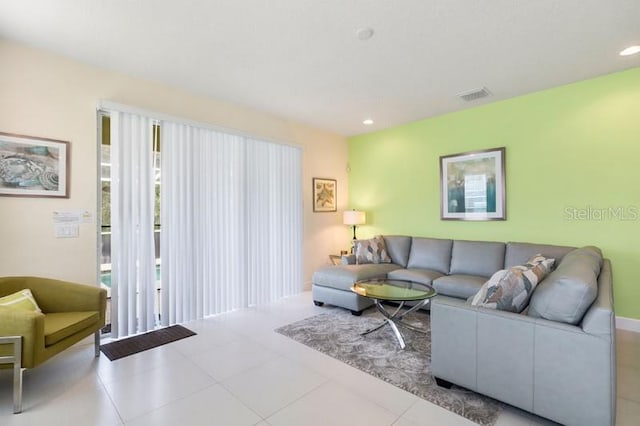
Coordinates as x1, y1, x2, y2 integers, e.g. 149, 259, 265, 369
312, 236, 616, 425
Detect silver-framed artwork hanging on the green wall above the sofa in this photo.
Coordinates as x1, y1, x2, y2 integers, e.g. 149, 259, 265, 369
440, 148, 507, 220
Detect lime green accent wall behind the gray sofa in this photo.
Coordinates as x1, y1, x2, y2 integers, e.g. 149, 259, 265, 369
348, 68, 640, 319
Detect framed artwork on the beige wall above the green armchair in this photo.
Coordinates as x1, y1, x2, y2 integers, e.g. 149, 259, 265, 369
0, 132, 69, 198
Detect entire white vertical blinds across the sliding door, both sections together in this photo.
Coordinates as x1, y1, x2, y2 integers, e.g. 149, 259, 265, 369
111, 105, 302, 336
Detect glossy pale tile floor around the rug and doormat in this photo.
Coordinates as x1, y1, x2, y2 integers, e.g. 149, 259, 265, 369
0, 292, 640, 426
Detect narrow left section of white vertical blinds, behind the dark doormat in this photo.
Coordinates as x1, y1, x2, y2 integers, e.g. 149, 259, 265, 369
110, 112, 157, 338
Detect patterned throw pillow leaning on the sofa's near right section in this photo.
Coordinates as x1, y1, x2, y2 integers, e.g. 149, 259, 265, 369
471, 254, 555, 313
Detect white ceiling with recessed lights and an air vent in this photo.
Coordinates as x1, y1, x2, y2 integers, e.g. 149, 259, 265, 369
0, 0, 640, 135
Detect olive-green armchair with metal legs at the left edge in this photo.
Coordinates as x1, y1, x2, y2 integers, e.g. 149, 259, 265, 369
0, 277, 107, 413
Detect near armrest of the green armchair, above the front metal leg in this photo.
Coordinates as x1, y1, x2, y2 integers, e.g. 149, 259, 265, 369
0, 306, 44, 368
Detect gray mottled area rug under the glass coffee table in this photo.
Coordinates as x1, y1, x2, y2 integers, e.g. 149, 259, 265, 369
275, 308, 502, 426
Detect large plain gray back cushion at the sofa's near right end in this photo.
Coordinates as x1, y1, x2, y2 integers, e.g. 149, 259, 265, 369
528, 247, 602, 325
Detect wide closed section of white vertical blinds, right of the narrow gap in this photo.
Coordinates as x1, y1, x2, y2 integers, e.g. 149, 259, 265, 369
160, 122, 302, 325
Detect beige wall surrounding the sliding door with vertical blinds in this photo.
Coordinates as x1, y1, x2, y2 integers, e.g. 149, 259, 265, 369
0, 41, 349, 288
